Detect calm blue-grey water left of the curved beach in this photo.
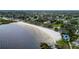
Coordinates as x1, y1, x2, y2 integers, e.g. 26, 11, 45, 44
0, 24, 40, 49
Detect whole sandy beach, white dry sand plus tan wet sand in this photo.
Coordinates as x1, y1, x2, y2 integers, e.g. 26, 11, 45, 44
17, 22, 61, 45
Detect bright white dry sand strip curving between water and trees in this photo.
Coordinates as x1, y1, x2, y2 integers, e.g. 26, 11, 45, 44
17, 22, 61, 45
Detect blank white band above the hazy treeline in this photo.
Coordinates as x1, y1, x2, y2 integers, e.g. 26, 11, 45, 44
0, 0, 79, 10
